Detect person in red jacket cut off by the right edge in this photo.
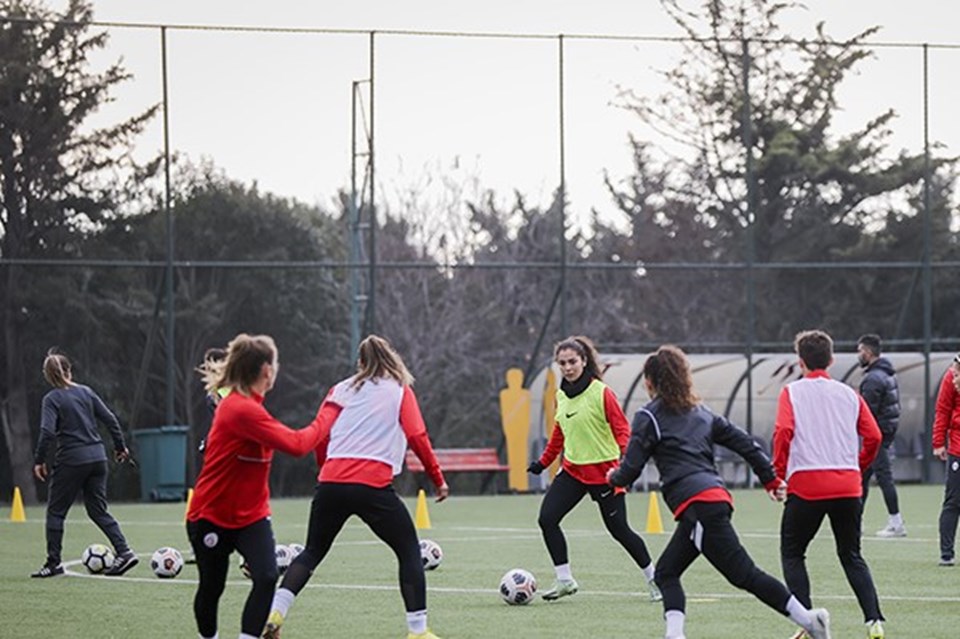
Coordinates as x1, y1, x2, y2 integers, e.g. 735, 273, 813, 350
933, 353, 960, 566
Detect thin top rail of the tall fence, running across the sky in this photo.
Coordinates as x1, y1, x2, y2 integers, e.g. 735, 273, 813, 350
0, 16, 960, 49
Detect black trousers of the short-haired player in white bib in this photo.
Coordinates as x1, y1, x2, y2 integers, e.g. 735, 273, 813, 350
780, 495, 883, 621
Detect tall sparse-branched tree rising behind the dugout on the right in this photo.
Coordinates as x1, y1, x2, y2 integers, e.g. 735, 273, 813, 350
621, 0, 940, 342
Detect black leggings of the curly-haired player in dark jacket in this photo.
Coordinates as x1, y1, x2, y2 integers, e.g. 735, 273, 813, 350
656, 502, 790, 615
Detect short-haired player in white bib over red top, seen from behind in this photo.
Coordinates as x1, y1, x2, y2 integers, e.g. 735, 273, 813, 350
773, 330, 884, 639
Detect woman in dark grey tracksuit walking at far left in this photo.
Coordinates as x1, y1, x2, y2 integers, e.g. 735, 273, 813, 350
30, 350, 139, 578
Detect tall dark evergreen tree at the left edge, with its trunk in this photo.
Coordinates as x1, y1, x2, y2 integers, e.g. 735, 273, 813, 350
0, 0, 155, 501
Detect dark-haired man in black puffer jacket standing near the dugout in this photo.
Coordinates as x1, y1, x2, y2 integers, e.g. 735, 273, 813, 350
857, 333, 907, 537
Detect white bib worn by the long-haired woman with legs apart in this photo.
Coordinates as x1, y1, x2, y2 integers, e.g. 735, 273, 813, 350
327, 377, 407, 475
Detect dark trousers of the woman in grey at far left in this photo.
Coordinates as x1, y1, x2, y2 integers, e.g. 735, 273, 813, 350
47, 461, 130, 566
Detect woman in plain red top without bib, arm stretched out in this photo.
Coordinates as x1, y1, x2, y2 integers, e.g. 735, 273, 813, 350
187, 333, 329, 639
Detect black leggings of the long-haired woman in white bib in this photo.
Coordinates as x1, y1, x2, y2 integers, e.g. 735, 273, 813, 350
280, 482, 427, 612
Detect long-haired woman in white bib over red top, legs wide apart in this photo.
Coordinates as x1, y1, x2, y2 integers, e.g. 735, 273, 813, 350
263, 335, 450, 639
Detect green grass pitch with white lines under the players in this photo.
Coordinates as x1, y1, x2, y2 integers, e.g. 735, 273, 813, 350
0, 486, 960, 639
